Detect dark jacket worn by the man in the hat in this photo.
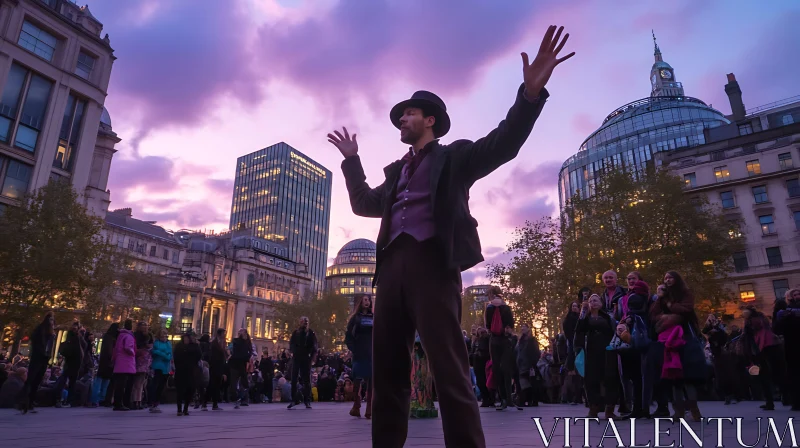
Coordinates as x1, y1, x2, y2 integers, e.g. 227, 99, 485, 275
342, 85, 550, 284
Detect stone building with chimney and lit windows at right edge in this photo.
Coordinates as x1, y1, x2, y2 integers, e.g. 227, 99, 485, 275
655, 74, 800, 317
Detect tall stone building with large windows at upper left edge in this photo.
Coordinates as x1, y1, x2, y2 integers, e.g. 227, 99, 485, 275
0, 0, 119, 216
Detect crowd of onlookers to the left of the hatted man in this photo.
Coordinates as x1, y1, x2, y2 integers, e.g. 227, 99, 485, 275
0, 296, 372, 418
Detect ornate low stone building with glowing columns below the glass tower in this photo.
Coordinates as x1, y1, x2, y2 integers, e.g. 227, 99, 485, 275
99, 213, 311, 353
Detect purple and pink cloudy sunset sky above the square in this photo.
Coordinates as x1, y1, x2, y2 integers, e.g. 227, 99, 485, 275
90, 0, 800, 285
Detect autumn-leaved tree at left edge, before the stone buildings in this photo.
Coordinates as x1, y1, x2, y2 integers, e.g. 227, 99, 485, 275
0, 180, 166, 352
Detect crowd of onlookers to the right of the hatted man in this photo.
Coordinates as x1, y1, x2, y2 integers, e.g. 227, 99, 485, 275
465, 271, 800, 421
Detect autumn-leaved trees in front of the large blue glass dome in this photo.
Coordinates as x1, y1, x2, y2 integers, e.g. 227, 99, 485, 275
488, 168, 744, 335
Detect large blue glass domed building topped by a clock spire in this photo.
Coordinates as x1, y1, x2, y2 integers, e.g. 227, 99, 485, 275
558, 37, 730, 212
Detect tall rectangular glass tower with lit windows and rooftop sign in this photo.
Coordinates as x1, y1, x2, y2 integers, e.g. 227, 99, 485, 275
230, 142, 332, 292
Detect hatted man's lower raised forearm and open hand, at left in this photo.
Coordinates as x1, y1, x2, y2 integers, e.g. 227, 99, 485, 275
328, 128, 385, 218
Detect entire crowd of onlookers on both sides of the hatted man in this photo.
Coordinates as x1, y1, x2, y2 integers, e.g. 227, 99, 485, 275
0, 271, 800, 420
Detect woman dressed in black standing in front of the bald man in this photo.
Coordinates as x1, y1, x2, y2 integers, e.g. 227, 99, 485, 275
575, 294, 619, 419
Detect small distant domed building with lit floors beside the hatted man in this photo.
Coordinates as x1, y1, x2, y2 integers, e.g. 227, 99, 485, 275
325, 238, 376, 305
